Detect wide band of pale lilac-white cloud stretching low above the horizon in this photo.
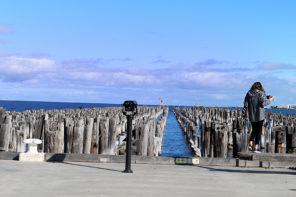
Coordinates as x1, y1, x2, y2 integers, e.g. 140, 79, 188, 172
0, 53, 296, 105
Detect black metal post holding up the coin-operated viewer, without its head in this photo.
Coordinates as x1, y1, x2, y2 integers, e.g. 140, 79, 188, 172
123, 115, 133, 173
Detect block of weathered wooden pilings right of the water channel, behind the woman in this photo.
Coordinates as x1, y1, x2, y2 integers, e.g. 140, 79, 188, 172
174, 106, 296, 158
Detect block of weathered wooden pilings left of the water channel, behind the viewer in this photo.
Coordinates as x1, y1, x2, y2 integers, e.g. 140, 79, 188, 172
0, 106, 168, 156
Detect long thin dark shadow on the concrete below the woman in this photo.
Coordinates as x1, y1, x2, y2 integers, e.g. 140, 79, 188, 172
197, 166, 296, 175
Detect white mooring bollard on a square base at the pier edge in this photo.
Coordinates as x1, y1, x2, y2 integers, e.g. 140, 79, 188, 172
19, 138, 44, 161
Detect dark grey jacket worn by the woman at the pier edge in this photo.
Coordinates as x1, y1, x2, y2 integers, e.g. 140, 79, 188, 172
242, 89, 270, 122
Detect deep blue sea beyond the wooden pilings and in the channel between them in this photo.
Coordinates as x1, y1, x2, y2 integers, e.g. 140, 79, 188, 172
0, 100, 296, 157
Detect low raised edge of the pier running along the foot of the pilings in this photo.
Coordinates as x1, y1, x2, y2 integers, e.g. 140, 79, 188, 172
0, 152, 296, 169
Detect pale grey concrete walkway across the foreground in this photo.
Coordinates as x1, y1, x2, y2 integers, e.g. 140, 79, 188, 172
0, 160, 296, 197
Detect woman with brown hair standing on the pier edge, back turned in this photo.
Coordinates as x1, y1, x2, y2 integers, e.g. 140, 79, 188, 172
242, 82, 274, 152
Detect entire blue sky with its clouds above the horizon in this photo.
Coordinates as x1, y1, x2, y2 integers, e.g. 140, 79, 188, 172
0, 0, 296, 107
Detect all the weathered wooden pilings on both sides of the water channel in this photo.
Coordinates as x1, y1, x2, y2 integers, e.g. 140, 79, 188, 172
0, 106, 296, 158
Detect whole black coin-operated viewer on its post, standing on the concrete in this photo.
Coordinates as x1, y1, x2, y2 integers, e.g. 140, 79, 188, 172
122, 101, 138, 173
